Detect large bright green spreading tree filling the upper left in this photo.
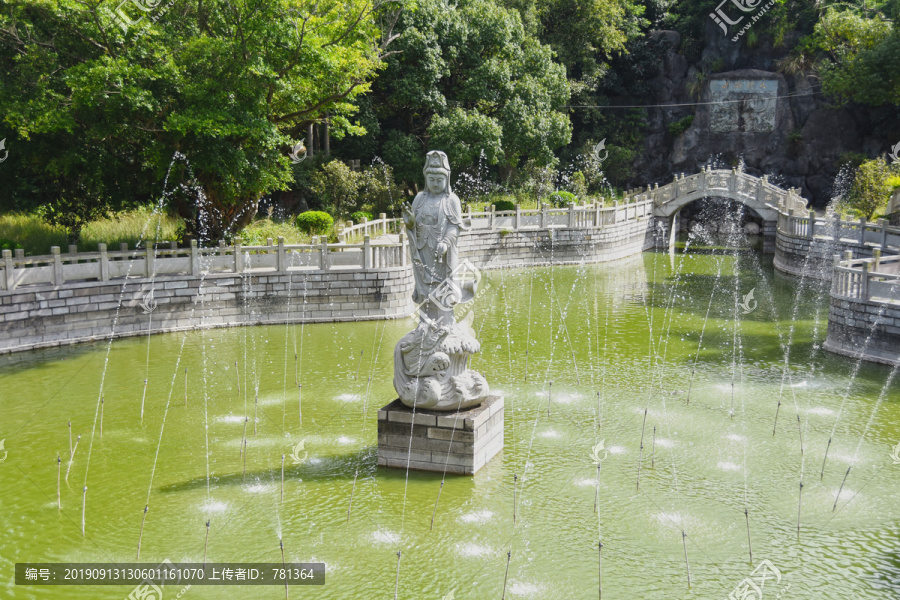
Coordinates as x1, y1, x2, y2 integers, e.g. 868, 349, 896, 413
0, 0, 399, 239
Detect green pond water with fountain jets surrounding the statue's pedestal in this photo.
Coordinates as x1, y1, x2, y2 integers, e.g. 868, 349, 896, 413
0, 248, 900, 600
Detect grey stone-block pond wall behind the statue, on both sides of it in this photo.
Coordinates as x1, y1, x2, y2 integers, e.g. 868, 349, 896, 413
0, 218, 654, 353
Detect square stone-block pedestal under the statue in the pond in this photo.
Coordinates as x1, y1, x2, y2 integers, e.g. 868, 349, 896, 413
378, 396, 503, 475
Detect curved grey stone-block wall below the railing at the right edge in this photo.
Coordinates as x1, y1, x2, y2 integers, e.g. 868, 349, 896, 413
824, 296, 900, 365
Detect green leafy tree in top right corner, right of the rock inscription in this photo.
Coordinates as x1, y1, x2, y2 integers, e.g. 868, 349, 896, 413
807, 7, 900, 106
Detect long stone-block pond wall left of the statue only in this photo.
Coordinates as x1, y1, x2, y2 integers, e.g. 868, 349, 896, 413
0, 267, 413, 353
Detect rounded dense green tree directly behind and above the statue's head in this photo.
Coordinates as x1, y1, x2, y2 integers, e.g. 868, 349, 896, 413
374, 0, 571, 187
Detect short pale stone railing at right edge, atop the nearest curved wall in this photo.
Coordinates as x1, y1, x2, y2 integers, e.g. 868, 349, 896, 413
831, 248, 900, 304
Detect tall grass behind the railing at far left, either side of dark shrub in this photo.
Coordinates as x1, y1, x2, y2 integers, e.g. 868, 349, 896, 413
0, 207, 182, 255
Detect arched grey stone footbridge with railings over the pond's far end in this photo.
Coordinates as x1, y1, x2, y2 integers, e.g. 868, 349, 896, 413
626, 169, 807, 247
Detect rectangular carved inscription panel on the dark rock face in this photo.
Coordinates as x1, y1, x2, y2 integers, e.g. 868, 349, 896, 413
709, 79, 778, 133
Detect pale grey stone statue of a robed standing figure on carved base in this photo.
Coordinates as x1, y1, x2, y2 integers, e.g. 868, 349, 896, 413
394, 150, 488, 410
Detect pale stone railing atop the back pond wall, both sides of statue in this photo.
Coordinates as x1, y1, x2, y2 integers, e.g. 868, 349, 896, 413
0, 200, 652, 291
